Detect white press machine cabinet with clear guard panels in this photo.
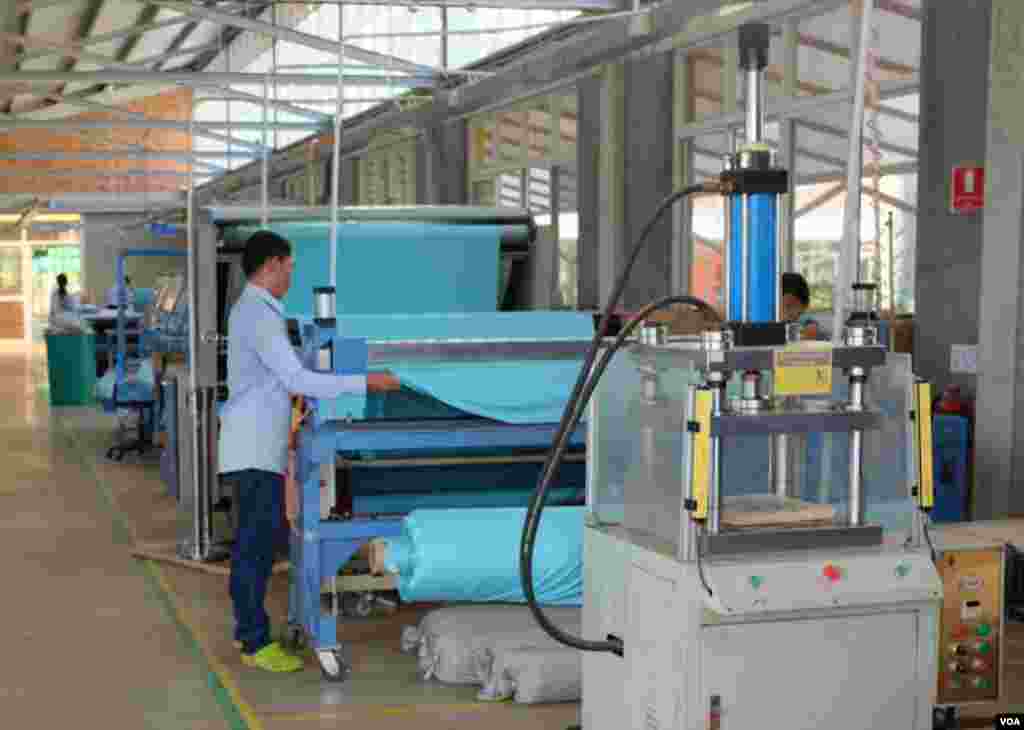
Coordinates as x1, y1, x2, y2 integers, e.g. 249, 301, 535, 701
582, 345, 942, 730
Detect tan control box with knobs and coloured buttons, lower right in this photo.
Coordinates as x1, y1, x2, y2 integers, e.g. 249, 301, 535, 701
938, 547, 1005, 704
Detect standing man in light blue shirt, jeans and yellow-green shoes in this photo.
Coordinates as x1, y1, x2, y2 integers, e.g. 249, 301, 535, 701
218, 230, 398, 672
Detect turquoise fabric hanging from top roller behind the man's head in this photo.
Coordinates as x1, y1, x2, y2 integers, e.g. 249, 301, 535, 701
233, 223, 502, 316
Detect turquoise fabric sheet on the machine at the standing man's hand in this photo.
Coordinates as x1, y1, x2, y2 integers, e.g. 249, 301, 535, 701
324, 312, 594, 424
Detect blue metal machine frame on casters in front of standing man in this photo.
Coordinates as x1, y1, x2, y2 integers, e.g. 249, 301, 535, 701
288, 328, 589, 680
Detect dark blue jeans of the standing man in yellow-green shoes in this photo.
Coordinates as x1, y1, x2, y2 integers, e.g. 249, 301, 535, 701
222, 469, 285, 654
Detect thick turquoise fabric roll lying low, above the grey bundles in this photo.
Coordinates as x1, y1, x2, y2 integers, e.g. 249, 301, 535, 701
387, 507, 584, 606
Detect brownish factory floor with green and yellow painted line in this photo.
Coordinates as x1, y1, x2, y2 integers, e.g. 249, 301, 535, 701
0, 343, 579, 730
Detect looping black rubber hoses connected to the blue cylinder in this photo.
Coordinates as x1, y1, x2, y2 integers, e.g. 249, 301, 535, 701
519, 183, 721, 655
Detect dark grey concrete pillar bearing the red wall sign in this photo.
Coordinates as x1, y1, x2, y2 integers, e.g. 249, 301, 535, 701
904, 0, 991, 391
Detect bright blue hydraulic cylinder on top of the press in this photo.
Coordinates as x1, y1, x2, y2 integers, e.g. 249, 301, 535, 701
728, 192, 781, 321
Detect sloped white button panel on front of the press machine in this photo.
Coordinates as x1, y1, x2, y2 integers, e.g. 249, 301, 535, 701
703, 548, 942, 616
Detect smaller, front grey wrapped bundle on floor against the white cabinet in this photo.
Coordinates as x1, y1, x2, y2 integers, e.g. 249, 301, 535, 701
476, 646, 583, 704
